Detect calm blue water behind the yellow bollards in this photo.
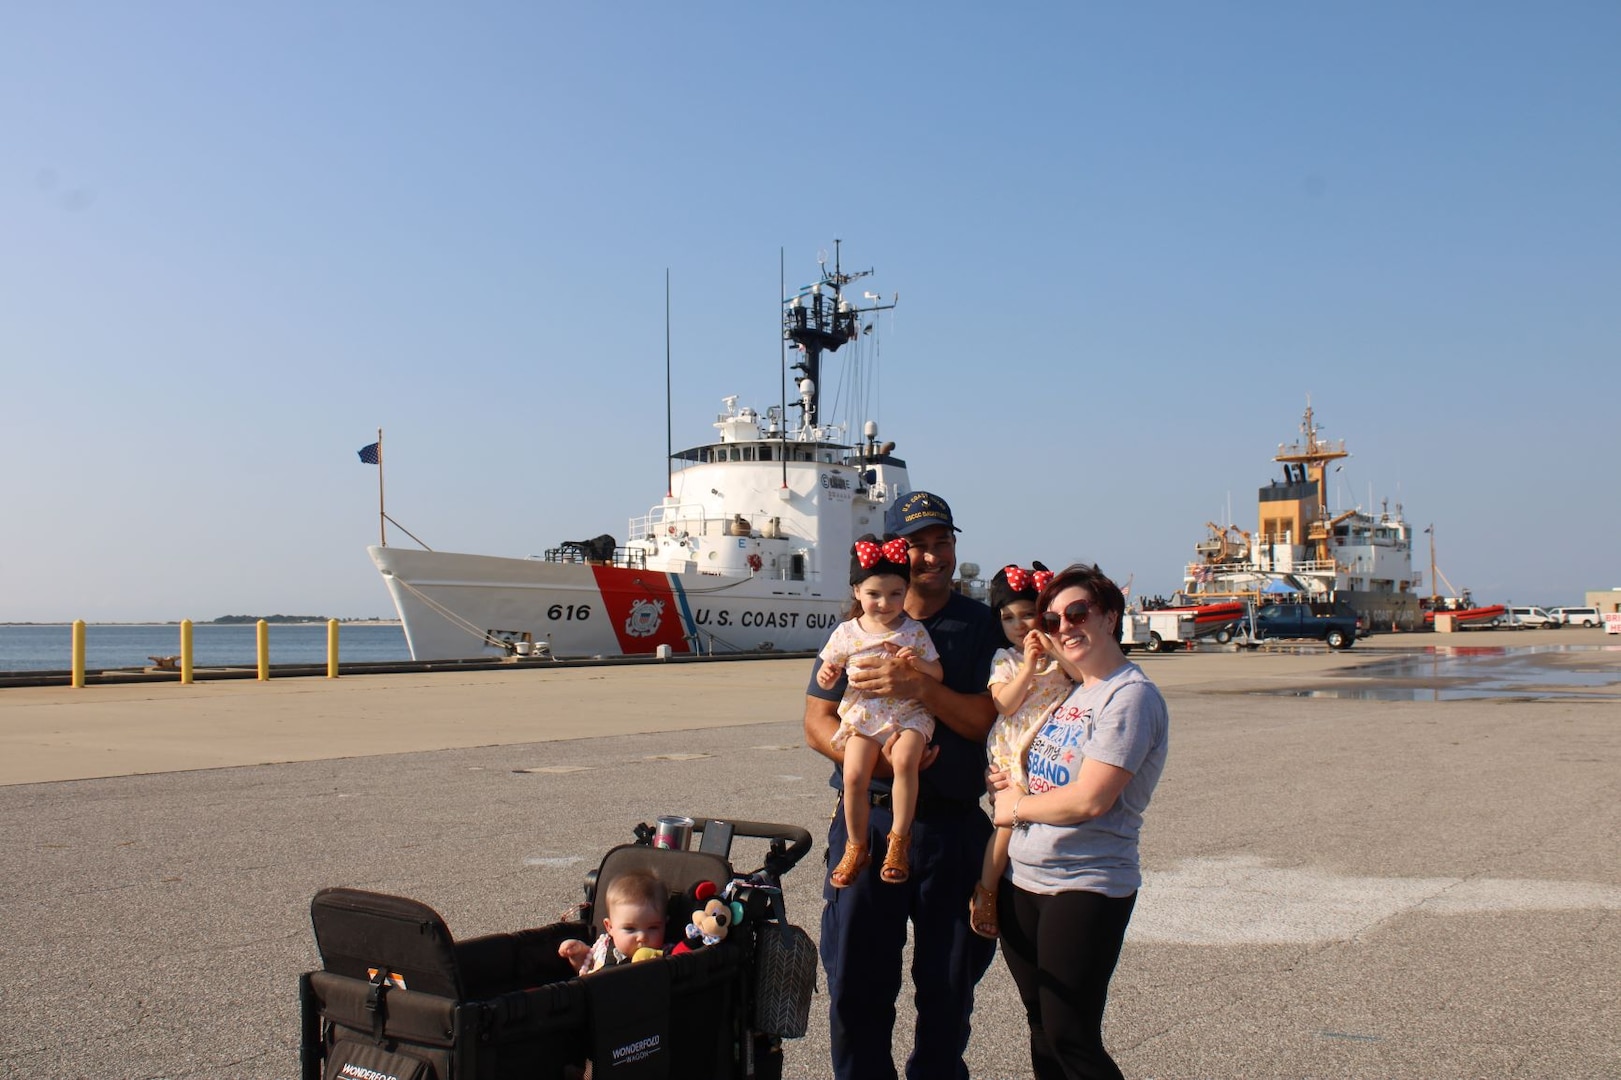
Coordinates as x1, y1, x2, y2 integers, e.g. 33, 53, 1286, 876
0, 623, 410, 671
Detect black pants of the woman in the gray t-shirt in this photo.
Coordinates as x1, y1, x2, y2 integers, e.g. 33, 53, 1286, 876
997, 879, 1136, 1080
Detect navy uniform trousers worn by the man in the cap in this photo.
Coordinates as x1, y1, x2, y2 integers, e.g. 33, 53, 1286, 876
822, 791, 995, 1080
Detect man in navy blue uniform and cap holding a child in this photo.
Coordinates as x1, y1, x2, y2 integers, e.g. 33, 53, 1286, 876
806, 491, 1002, 1080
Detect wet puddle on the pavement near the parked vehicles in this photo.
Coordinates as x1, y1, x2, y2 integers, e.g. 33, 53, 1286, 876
1250, 644, 1621, 701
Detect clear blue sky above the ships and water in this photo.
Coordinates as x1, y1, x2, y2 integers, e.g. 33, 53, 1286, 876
0, 0, 1621, 621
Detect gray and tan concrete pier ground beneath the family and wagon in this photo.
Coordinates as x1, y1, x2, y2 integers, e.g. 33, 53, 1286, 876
0, 629, 1621, 1078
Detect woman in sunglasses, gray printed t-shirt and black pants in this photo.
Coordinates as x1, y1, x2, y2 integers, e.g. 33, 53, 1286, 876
990, 564, 1170, 1080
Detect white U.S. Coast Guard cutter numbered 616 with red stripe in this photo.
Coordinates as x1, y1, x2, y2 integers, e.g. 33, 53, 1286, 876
366, 246, 911, 660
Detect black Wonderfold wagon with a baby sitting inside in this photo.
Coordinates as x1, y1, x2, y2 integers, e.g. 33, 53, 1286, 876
300, 817, 815, 1080
